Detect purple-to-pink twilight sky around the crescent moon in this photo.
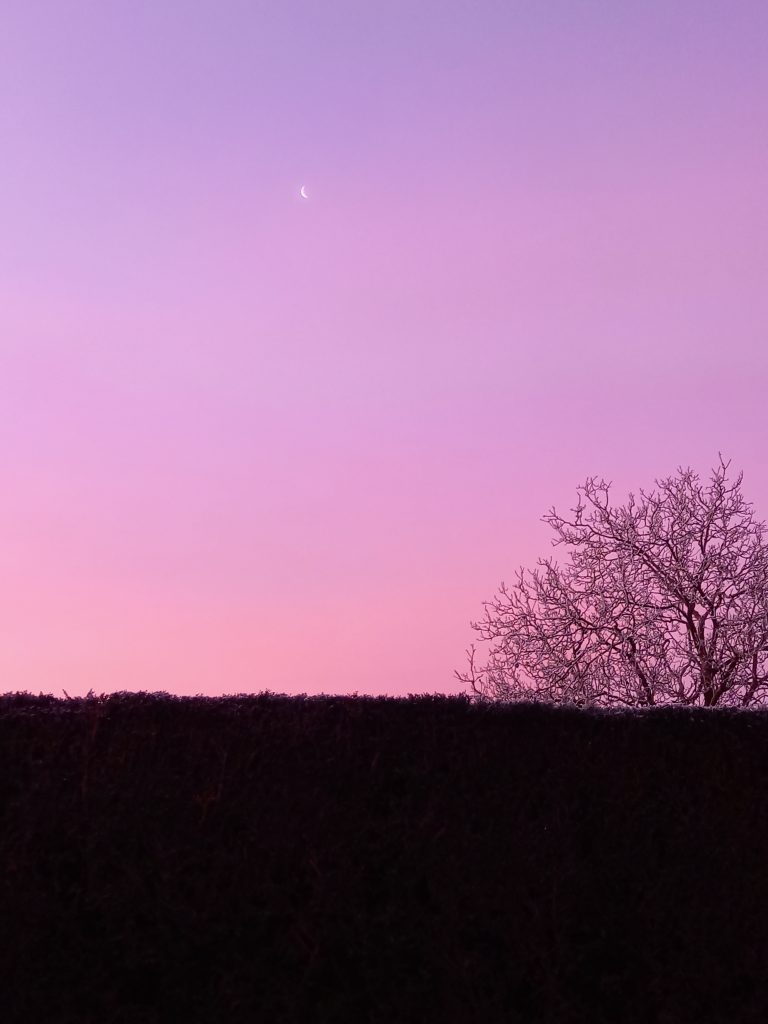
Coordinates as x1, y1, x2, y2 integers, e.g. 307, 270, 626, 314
0, 0, 768, 696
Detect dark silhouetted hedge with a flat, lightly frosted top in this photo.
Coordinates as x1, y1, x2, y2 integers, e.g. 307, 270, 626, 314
0, 693, 768, 1024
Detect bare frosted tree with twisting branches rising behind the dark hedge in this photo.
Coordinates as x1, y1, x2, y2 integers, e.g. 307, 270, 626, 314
455, 456, 768, 707
